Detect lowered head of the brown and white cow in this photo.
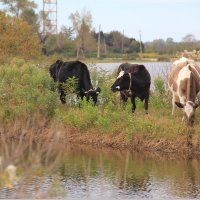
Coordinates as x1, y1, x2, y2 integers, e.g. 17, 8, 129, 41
175, 101, 200, 126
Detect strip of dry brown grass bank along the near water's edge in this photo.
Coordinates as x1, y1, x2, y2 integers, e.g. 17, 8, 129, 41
0, 117, 200, 157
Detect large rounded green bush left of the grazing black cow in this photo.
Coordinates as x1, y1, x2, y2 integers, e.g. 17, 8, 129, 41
0, 59, 56, 117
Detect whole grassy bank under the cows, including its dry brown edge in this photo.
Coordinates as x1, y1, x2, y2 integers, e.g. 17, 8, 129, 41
0, 59, 200, 159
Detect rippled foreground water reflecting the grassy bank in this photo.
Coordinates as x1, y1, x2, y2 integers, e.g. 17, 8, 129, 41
0, 145, 200, 200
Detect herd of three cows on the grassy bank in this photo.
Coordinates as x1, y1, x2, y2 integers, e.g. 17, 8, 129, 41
49, 57, 200, 126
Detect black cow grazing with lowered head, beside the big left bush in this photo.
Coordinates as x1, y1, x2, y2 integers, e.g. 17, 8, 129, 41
49, 60, 101, 104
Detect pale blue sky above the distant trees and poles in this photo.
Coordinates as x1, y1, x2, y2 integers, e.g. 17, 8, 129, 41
1, 0, 200, 42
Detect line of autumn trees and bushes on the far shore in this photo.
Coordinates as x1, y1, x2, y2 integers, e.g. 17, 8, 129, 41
0, 0, 200, 59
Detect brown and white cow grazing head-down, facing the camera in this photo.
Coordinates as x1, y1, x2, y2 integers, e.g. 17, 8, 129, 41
168, 57, 200, 126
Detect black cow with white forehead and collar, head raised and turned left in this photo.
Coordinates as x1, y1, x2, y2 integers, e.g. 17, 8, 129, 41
111, 65, 151, 113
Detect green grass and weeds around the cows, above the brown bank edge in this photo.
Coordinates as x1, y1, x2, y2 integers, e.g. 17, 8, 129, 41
0, 59, 200, 142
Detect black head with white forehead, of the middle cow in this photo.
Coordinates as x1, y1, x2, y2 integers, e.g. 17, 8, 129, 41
111, 71, 131, 92
